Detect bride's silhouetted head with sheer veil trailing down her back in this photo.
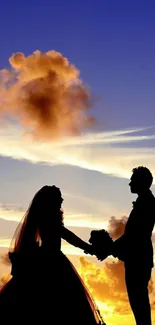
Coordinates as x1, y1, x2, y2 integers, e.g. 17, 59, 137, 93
10, 185, 63, 252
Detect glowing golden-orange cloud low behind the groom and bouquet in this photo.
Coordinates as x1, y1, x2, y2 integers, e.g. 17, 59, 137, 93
79, 217, 155, 325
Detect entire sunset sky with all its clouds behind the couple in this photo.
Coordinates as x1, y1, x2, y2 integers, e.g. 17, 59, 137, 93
0, 0, 155, 325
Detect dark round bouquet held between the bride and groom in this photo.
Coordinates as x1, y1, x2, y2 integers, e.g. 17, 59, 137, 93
89, 229, 113, 261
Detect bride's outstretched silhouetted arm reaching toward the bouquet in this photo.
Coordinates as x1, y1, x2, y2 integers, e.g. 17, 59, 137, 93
61, 226, 93, 255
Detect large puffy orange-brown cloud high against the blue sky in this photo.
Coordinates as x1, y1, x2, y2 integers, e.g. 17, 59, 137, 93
0, 51, 94, 139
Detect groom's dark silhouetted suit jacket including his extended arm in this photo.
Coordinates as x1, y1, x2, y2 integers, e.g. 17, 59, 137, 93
113, 190, 155, 267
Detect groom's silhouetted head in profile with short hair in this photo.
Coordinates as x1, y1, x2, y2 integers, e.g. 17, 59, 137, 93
129, 166, 153, 194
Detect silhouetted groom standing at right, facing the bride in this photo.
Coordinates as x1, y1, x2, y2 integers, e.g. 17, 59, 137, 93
113, 167, 155, 325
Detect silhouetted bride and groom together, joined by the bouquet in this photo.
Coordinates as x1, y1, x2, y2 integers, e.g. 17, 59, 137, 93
0, 167, 155, 325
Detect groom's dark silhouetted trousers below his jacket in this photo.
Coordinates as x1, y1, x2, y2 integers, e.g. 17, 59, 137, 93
125, 262, 152, 325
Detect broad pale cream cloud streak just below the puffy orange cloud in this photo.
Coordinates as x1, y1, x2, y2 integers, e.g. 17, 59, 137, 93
0, 125, 155, 182
